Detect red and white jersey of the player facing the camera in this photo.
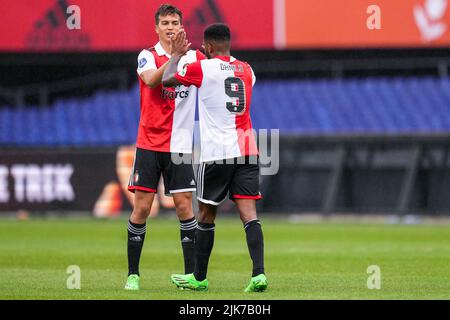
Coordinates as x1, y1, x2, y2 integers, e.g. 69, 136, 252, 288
136, 43, 205, 153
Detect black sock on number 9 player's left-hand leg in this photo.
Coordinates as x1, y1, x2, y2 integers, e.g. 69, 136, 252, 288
194, 222, 215, 281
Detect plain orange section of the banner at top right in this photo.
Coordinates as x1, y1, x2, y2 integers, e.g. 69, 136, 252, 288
284, 0, 450, 48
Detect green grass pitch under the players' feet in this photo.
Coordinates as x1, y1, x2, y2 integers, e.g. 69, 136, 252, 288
0, 216, 450, 300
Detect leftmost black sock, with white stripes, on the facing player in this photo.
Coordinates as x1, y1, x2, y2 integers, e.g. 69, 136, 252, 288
127, 221, 146, 275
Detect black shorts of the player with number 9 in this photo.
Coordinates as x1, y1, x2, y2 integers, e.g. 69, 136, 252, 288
197, 157, 261, 206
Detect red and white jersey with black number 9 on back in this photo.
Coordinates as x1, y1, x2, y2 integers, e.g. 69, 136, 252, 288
175, 56, 258, 162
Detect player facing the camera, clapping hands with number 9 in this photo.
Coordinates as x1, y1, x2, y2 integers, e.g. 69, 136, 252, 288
125, 4, 205, 290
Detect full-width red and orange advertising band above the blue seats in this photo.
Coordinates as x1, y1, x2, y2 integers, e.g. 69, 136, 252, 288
0, 0, 450, 52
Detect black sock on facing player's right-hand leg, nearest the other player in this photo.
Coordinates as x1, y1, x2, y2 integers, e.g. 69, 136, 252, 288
180, 217, 197, 274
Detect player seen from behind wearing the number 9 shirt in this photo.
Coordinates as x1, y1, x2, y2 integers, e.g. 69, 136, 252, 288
163, 23, 268, 292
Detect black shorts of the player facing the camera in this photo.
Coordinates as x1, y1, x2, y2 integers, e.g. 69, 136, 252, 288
128, 148, 195, 195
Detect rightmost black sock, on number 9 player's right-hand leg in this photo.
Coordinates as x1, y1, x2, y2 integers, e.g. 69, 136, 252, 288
244, 219, 264, 277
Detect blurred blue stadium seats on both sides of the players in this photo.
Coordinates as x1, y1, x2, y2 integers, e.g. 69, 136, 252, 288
0, 76, 450, 147
